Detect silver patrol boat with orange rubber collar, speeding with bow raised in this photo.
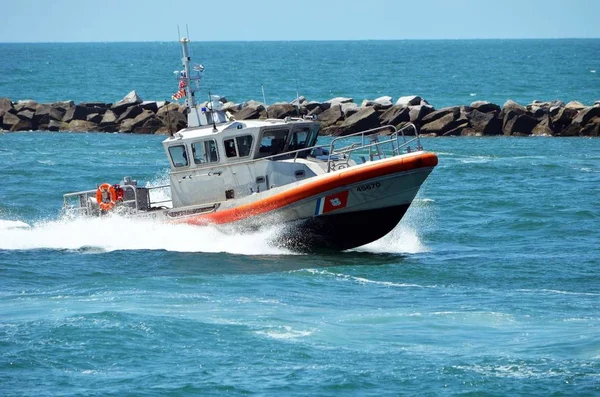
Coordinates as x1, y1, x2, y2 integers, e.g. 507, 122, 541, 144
64, 38, 438, 252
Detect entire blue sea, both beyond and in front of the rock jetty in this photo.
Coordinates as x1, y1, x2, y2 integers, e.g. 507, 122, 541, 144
0, 40, 600, 396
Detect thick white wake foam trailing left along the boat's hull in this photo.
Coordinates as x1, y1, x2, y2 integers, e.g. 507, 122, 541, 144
0, 215, 291, 255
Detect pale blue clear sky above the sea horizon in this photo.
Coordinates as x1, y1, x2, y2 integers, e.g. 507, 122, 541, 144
0, 0, 600, 42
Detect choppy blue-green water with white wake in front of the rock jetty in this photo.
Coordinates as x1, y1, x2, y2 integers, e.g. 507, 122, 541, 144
0, 132, 600, 396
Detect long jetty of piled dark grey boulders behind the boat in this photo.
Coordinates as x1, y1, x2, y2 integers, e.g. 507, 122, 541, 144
0, 91, 600, 136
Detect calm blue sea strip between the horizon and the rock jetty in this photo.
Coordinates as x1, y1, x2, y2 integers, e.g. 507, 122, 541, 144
0, 39, 600, 108
